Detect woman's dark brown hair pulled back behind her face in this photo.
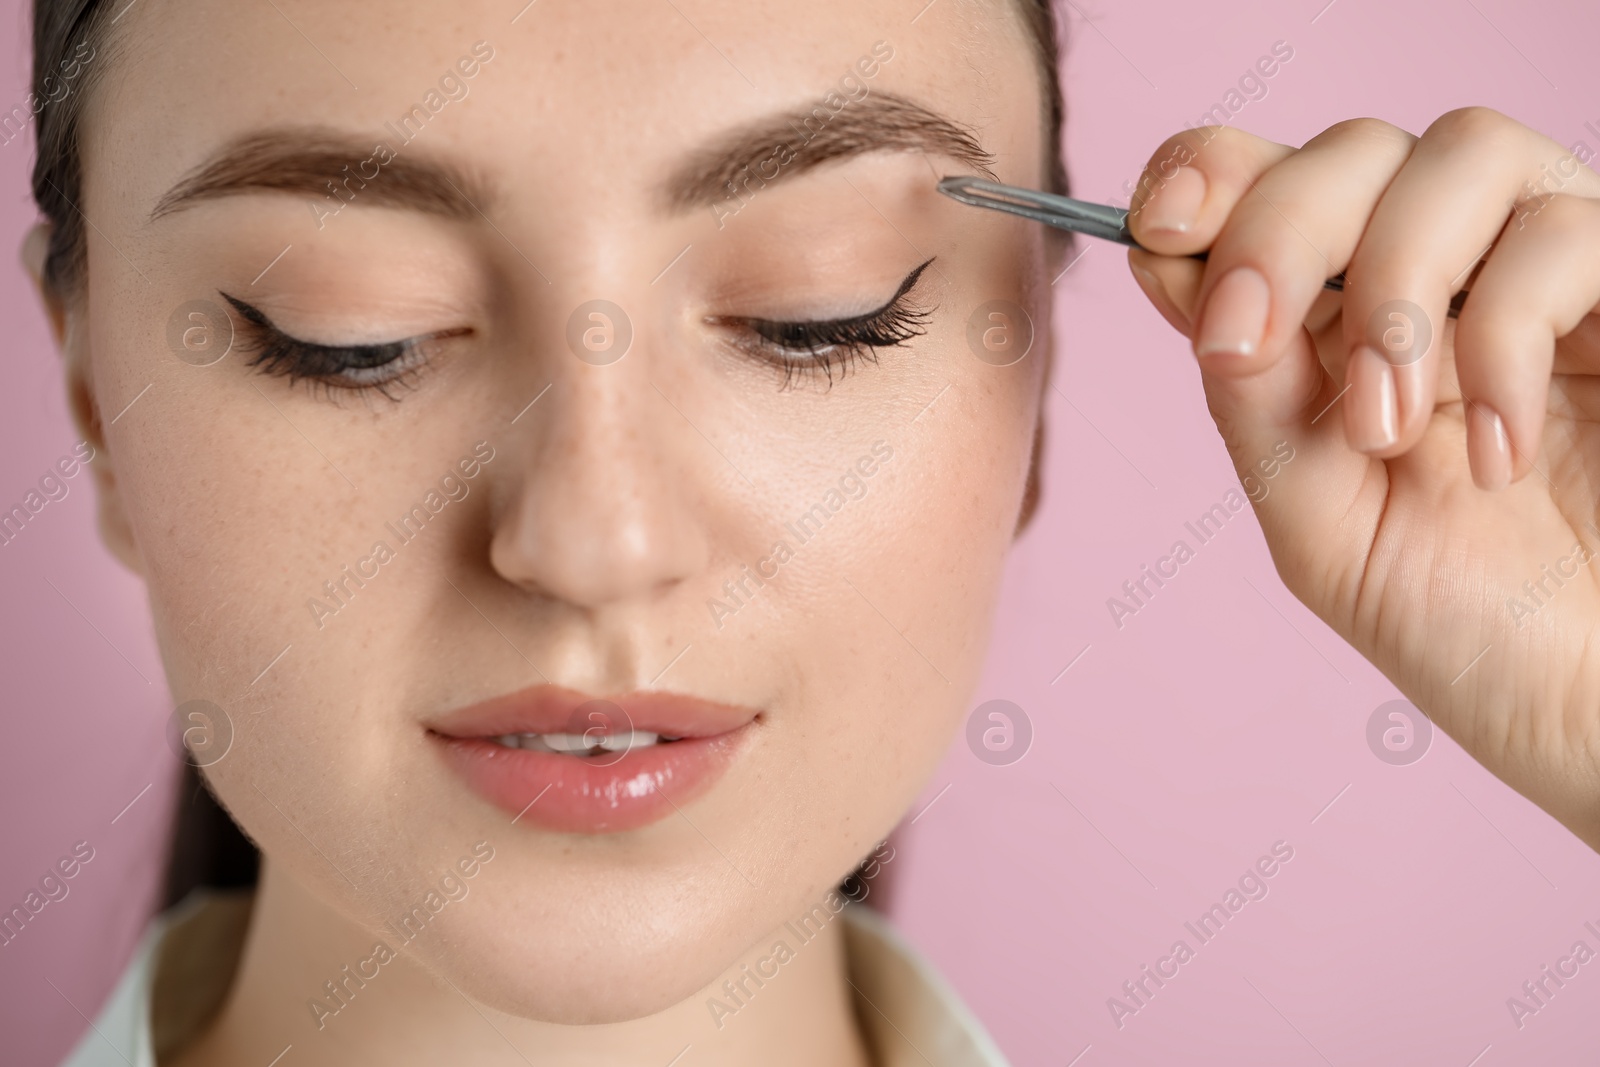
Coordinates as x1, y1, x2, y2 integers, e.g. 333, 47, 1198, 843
30, 0, 1070, 905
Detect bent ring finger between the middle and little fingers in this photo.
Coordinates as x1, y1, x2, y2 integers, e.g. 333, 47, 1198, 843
1344, 107, 1600, 458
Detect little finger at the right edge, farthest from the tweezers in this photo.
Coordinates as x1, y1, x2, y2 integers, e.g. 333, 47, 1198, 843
1454, 195, 1600, 490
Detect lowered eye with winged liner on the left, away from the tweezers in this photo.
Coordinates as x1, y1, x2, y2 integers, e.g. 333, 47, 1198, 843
221, 293, 466, 400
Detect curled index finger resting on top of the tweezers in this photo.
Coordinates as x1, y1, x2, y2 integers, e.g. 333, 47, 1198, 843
1128, 126, 1294, 256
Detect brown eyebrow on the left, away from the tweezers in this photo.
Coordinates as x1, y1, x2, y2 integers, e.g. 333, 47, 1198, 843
150, 126, 490, 219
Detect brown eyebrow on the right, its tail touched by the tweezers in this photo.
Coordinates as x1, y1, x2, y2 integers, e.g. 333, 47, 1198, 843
658, 91, 998, 211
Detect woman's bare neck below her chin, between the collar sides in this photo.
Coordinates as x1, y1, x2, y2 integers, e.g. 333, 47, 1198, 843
163, 861, 869, 1067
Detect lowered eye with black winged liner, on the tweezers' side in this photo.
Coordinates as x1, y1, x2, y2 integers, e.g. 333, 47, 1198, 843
707, 259, 936, 386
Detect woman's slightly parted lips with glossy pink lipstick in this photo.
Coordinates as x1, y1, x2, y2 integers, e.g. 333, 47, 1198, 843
427, 685, 760, 833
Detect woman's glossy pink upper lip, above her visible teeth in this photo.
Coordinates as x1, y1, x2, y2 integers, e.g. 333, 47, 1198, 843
426, 685, 758, 737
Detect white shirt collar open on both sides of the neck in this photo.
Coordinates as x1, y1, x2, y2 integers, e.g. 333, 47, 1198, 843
61, 889, 1008, 1067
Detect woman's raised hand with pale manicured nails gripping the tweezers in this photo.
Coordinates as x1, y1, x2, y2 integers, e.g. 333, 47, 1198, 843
1130, 107, 1600, 849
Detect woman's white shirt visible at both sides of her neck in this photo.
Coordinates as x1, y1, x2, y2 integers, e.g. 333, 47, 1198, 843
61, 889, 1008, 1067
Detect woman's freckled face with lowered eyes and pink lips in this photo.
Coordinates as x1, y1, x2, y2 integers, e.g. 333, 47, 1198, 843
67, 0, 1053, 1022
